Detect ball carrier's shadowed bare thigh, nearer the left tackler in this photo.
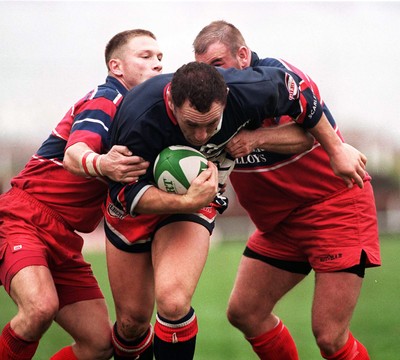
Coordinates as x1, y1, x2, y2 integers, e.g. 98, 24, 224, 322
106, 241, 154, 319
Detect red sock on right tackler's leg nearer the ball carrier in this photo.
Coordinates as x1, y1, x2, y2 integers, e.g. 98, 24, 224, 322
247, 320, 299, 360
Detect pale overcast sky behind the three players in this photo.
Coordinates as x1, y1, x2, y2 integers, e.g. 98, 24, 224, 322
0, 0, 400, 148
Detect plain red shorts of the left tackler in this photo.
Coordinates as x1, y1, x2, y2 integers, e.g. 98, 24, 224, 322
0, 188, 103, 308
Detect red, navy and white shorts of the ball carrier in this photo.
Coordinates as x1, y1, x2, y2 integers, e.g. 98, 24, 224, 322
104, 196, 217, 253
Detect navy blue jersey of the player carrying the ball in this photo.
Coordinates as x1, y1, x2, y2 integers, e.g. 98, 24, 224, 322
110, 66, 322, 215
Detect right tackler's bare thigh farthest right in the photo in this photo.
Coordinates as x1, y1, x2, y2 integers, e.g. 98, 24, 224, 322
312, 272, 363, 336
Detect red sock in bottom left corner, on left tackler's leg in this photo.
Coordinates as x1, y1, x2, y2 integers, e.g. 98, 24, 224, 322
0, 323, 39, 360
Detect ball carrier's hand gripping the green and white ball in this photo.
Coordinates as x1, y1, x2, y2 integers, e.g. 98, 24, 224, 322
182, 161, 218, 211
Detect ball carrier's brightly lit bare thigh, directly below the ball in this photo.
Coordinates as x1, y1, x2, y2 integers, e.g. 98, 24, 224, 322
152, 221, 210, 315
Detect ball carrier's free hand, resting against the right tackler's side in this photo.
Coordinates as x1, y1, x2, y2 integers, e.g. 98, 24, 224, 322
330, 143, 367, 188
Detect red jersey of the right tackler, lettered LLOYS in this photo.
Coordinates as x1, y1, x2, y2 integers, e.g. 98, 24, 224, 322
230, 53, 370, 232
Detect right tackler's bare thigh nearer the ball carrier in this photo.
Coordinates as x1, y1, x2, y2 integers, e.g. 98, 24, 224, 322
229, 256, 306, 317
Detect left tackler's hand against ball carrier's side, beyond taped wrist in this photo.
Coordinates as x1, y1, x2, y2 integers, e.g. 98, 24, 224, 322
100, 145, 149, 183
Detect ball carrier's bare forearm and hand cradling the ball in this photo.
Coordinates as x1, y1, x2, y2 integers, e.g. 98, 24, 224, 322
133, 162, 218, 214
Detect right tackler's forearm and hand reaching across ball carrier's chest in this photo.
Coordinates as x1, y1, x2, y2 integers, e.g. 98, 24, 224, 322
226, 123, 314, 158
